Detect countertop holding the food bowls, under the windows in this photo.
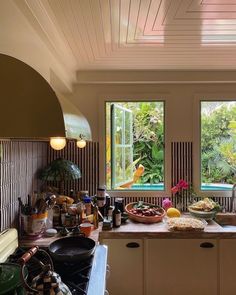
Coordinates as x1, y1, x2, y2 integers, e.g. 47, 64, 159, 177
99, 216, 236, 242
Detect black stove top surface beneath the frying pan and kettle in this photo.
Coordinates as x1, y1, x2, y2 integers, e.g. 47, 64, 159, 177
7, 248, 94, 295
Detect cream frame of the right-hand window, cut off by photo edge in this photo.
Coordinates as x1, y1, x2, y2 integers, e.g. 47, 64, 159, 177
193, 93, 236, 197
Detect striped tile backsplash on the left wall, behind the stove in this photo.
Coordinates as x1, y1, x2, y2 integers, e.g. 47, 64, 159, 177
0, 141, 47, 230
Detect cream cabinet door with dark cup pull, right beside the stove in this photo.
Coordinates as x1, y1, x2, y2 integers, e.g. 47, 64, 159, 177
103, 239, 143, 295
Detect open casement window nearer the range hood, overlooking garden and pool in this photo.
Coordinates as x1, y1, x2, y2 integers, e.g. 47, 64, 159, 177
106, 101, 164, 191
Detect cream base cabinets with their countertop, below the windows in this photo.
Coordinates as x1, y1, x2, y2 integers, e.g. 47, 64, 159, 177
99, 220, 236, 295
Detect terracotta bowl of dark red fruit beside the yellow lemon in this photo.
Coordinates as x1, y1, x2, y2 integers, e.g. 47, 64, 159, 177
125, 201, 165, 223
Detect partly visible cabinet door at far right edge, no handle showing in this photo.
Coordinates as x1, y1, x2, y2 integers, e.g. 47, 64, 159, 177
219, 239, 236, 295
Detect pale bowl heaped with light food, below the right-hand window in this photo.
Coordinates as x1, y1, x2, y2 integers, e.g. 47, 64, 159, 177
188, 198, 220, 220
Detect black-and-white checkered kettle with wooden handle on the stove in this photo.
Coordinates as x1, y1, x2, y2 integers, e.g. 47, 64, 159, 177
18, 246, 72, 295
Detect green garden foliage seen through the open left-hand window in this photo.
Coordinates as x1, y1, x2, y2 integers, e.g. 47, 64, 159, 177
106, 101, 164, 188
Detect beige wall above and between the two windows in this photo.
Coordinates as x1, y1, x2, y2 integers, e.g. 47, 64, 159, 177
71, 84, 236, 141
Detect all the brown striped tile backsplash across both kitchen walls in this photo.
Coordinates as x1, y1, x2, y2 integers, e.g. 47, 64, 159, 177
0, 141, 232, 231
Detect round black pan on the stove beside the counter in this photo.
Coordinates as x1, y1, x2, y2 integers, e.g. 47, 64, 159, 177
48, 237, 96, 262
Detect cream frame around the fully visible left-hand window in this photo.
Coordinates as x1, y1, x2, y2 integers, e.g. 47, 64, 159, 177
99, 93, 171, 197
